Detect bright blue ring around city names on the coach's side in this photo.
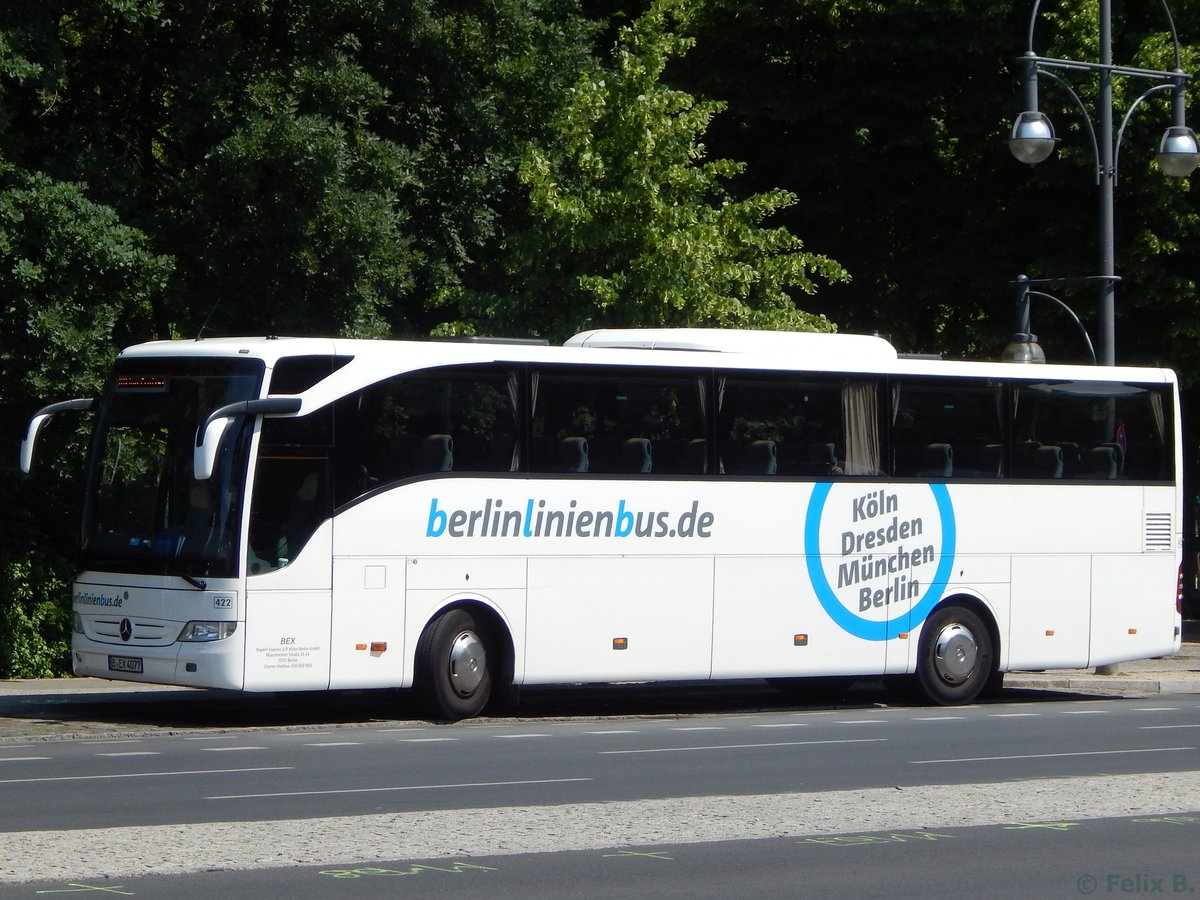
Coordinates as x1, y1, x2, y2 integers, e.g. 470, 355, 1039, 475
804, 481, 956, 641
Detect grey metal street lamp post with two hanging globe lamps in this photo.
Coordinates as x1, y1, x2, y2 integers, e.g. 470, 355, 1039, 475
1008, 0, 1200, 366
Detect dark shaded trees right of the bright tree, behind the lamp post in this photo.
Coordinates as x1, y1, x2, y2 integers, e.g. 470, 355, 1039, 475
668, 0, 1200, 378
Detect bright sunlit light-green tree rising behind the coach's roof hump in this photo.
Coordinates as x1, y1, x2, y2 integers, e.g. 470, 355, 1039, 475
442, 0, 845, 338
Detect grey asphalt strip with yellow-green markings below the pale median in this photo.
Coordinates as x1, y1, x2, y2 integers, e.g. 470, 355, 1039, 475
0, 815, 1200, 900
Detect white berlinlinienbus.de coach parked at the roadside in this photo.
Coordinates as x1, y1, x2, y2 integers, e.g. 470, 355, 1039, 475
22, 329, 1183, 719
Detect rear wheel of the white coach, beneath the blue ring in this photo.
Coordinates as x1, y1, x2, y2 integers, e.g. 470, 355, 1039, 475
917, 605, 995, 706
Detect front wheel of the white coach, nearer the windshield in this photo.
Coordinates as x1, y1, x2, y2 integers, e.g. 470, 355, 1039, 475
415, 610, 492, 721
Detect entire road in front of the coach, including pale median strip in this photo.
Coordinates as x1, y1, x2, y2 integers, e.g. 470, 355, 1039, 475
0, 691, 1200, 898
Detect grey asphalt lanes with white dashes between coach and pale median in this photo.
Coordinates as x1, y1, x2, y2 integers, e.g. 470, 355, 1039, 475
0, 697, 1200, 832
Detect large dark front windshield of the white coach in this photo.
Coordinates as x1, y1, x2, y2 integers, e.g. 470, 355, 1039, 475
80, 358, 264, 580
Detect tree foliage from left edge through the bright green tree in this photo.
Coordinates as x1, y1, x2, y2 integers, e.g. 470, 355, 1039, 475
0, 0, 841, 674
